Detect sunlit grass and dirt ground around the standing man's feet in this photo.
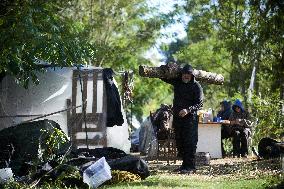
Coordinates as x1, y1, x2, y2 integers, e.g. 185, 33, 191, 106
102, 158, 284, 189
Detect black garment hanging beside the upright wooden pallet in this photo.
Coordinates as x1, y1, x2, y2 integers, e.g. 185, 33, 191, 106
103, 68, 124, 127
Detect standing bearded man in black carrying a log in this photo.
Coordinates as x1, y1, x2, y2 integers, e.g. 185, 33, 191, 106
162, 64, 203, 173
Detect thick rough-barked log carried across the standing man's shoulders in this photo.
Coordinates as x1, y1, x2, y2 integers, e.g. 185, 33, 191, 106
139, 64, 224, 85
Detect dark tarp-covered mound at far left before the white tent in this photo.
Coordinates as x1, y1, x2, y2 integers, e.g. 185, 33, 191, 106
0, 119, 69, 175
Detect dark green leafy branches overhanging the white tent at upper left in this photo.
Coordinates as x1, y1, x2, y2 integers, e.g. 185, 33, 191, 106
0, 0, 90, 87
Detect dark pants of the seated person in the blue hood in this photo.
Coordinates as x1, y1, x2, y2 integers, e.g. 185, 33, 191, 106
232, 128, 250, 156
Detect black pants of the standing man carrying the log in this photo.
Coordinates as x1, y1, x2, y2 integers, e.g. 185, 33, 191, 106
173, 115, 198, 168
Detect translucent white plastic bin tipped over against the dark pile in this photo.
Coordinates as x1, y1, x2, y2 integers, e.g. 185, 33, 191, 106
83, 157, 111, 188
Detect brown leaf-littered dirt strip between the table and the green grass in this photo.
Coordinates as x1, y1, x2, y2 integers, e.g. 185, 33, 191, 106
148, 158, 283, 180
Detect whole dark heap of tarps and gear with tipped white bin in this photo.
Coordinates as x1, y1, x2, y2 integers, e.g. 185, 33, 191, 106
0, 120, 149, 188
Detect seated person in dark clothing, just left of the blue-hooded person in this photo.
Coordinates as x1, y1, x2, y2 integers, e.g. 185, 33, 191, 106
217, 100, 232, 156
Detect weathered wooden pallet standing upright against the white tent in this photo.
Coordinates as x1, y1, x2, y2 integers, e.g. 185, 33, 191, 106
67, 69, 107, 148
